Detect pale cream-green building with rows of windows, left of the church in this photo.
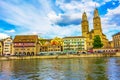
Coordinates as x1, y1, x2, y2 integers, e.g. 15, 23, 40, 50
63, 36, 86, 52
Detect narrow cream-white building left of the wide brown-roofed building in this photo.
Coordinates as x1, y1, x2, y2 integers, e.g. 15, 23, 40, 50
3, 37, 13, 55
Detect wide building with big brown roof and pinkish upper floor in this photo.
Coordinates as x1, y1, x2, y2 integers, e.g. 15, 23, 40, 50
13, 35, 39, 55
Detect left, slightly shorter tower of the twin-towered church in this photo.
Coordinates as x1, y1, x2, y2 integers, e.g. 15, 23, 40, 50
81, 12, 89, 37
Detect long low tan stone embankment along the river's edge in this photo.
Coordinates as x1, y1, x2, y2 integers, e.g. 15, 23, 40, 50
0, 52, 120, 60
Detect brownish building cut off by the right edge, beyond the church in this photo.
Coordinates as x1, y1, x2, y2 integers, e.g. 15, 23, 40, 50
112, 32, 120, 50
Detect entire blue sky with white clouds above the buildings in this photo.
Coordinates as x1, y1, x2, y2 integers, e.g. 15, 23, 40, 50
0, 0, 120, 40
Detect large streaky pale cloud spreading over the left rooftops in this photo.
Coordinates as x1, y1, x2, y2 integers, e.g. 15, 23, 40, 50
1, 0, 80, 37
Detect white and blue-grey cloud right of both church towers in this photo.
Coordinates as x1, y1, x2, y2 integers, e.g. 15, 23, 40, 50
101, 5, 120, 40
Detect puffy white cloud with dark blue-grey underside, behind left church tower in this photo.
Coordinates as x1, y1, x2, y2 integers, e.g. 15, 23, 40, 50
55, 0, 100, 26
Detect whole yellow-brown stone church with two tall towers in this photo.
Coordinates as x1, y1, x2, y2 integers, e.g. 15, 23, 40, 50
81, 8, 108, 49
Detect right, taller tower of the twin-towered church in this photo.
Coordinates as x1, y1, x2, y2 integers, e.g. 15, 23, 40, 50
93, 8, 102, 35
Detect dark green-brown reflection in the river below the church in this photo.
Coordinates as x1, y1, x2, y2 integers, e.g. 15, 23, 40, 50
85, 58, 108, 80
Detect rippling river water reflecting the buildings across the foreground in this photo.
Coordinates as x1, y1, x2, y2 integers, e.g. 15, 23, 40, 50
0, 57, 120, 80
